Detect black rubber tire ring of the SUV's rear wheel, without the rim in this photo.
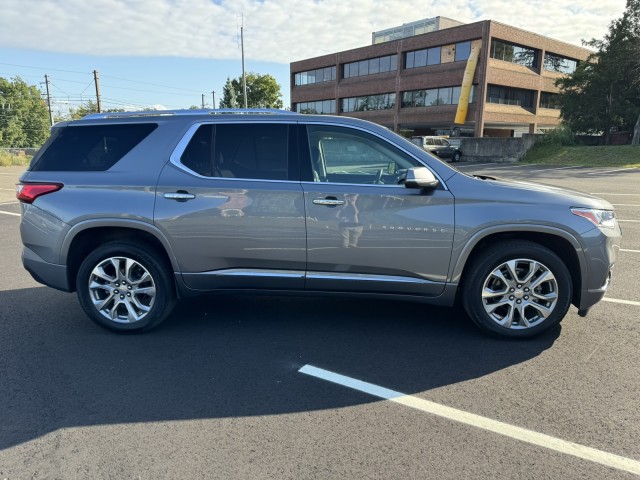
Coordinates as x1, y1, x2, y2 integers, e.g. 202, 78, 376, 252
76, 242, 175, 333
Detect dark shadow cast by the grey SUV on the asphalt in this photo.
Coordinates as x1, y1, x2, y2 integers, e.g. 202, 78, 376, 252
0, 288, 560, 449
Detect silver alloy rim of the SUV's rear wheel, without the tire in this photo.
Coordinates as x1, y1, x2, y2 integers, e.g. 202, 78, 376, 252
89, 257, 156, 323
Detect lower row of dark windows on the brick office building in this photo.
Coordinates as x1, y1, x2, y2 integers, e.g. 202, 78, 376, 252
296, 85, 560, 114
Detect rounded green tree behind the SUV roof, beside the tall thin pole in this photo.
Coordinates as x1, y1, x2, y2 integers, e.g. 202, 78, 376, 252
220, 72, 283, 108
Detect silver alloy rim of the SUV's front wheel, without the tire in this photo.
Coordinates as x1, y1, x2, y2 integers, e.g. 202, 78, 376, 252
482, 258, 558, 330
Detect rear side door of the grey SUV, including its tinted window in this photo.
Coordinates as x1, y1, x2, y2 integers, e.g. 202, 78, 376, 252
155, 122, 306, 290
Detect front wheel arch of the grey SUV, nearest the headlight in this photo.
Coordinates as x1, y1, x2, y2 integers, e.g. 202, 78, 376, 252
450, 225, 587, 306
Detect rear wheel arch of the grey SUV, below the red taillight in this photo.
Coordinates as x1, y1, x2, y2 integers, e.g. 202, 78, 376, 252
61, 219, 179, 291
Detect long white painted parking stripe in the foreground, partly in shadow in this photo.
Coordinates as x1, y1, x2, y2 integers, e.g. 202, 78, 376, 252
298, 365, 640, 475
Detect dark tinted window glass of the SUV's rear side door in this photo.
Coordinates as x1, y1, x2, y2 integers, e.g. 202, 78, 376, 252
180, 124, 289, 180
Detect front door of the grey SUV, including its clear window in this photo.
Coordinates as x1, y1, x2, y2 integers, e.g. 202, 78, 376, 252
302, 125, 454, 296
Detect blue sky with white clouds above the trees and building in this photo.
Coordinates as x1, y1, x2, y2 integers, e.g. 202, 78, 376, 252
0, 0, 625, 113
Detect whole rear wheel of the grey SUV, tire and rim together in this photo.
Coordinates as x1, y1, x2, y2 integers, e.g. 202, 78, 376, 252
76, 241, 176, 333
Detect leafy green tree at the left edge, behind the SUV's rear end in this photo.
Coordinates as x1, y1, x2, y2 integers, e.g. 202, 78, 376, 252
0, 77, 51, 147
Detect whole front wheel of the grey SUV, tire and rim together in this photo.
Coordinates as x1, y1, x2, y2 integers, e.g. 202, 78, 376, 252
462, 240, 573, 338
